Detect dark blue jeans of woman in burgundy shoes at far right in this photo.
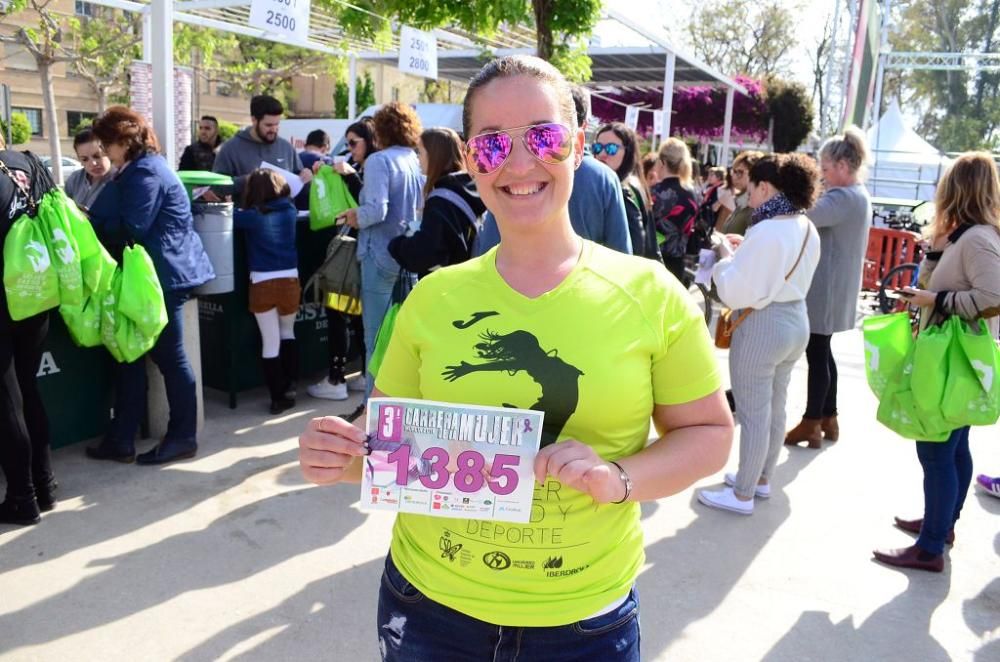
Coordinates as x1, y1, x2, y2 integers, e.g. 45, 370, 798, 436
917, 426, 972, 554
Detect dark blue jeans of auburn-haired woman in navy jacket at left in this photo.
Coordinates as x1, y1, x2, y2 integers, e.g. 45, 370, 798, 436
107, 290, 198, 451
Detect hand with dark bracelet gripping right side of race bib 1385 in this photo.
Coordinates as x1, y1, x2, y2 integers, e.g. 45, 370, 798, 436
535, 439, 625, 503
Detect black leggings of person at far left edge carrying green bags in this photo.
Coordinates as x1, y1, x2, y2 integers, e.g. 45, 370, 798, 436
0, 313, 52, 497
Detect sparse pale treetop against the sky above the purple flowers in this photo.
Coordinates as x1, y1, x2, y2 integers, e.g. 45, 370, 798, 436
689, 0, 797, 78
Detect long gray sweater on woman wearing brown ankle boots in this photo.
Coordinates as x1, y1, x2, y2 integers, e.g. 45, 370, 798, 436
806, 184, 872, 336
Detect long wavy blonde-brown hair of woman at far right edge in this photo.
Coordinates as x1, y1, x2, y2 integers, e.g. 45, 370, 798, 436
928, 152, 1000, 236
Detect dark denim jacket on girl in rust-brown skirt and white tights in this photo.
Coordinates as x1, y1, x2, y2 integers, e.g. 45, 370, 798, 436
233, 198, 299, 271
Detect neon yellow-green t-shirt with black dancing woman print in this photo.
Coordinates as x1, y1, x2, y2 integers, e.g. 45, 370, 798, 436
376, 241, 720, 627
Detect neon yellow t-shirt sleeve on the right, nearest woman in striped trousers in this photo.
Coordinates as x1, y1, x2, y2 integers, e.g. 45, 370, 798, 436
652, 272, 722, 405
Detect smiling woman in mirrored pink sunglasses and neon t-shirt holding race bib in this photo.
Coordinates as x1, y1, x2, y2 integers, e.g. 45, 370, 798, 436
299, 56, 733, 662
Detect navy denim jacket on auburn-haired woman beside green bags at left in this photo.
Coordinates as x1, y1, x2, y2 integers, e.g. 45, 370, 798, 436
90, 154, 215, 291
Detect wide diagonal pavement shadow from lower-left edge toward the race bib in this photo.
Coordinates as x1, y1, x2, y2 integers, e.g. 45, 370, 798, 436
0, 488, 373, 649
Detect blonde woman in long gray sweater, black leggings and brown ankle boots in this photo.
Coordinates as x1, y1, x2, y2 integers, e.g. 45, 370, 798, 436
785, 127, 872, 448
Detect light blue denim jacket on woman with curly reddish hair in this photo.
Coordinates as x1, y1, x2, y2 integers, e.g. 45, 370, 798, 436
358, 145, 424, 272
